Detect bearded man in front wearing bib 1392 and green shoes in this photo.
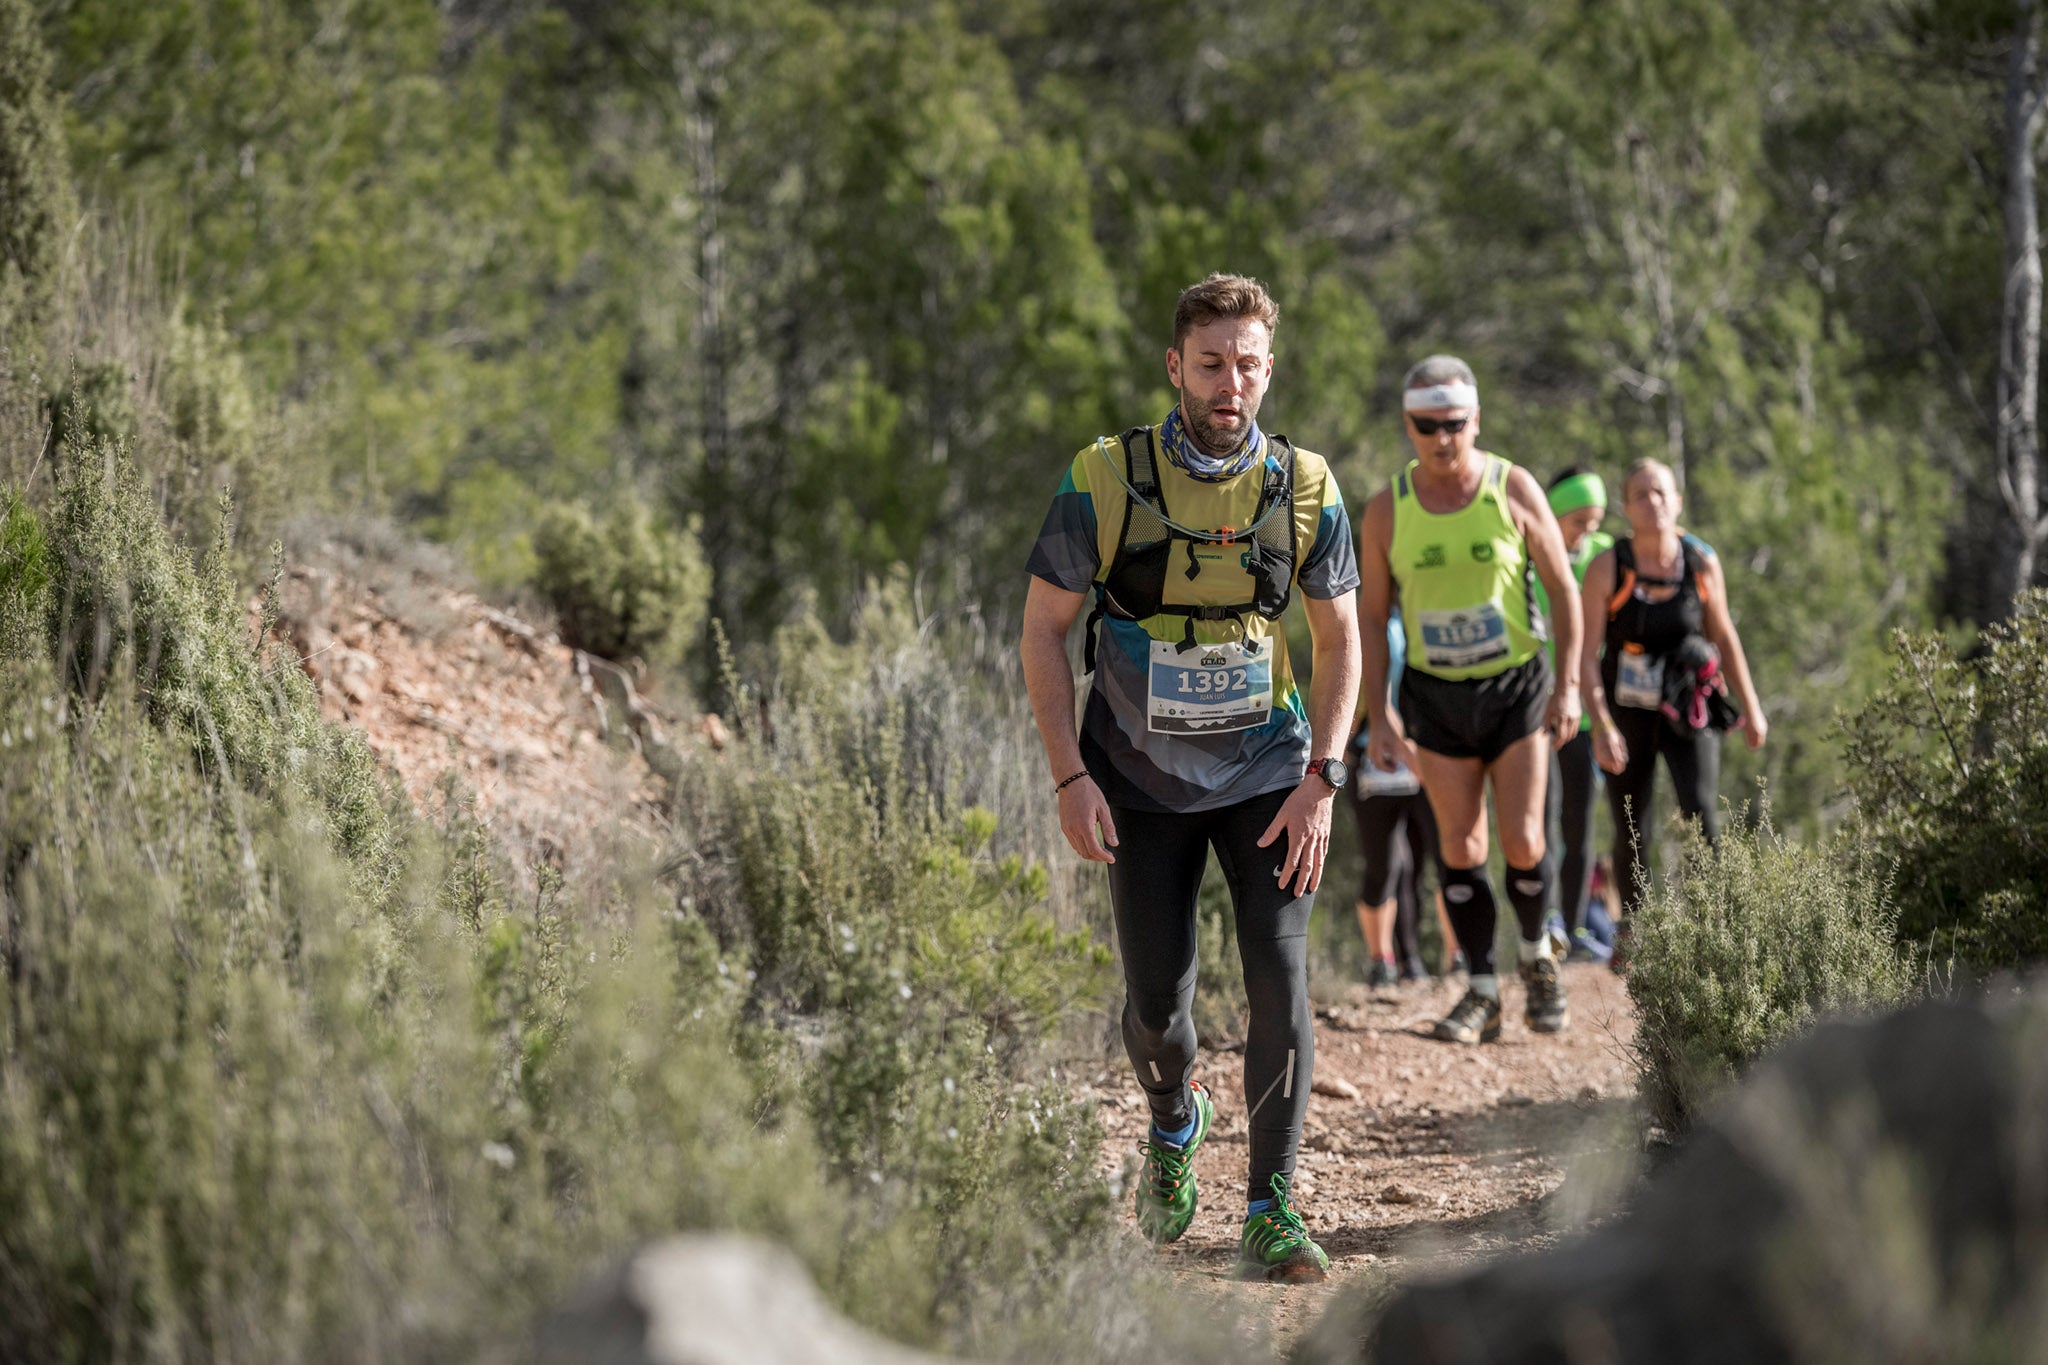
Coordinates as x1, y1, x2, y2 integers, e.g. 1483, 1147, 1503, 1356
1022, 274, 1359, 1279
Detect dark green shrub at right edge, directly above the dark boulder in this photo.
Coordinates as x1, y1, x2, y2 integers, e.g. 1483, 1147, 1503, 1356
1843, 589, 2048, 972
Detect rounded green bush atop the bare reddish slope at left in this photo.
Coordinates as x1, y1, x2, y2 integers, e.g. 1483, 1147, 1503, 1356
532, 501, 711, 669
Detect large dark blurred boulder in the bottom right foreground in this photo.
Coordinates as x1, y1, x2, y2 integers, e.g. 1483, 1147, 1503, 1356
1305, 982, 2048, 1365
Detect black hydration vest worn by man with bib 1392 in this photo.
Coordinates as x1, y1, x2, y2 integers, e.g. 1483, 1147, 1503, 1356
1083, 426, 1296, 673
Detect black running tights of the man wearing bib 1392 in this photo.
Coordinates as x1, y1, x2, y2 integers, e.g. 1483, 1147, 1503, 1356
1110, 790, 1315, 1199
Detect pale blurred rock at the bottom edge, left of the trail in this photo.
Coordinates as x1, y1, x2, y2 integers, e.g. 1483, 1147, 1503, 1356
535, 1236, 966, 1365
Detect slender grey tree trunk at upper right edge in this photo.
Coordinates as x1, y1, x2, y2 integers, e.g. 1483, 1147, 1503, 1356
1993, 0, 2048, 616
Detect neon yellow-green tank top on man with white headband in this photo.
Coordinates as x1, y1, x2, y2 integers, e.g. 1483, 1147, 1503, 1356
1386, 454, 1546, 681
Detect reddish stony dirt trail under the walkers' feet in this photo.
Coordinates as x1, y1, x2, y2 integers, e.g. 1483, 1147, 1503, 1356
1090, 966, 1634, 1345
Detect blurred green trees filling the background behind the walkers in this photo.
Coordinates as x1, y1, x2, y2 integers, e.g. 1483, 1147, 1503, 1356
10, 0, 2015, 827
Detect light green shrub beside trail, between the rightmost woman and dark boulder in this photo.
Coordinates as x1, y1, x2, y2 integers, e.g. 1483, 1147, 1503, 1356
1628, 819, 1915, 1130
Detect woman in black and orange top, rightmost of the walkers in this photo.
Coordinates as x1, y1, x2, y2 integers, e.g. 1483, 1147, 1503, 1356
1581, 460, 1769, 949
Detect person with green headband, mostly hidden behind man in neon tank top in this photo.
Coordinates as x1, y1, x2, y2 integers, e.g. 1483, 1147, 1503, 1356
1536, 465, 1614, 962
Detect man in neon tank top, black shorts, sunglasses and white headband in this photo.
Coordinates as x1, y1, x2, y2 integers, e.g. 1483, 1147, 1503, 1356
1358, 356, 1581, 1044
